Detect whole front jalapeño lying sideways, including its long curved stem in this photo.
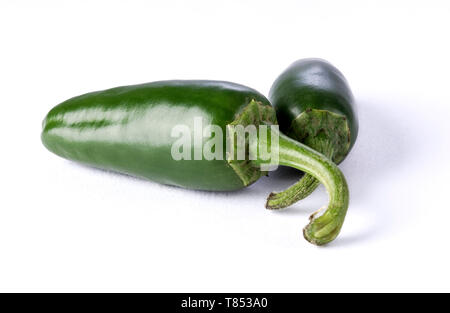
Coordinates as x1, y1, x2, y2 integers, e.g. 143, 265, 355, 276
42, 81, 348, 244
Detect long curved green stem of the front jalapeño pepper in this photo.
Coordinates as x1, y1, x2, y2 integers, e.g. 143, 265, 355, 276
250, 128, 349, 245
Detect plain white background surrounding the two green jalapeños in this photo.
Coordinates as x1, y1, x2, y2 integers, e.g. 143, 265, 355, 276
0, 0, 450, 292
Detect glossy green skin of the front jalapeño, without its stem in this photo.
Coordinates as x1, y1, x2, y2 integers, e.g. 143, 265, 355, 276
42, 81, 276, 191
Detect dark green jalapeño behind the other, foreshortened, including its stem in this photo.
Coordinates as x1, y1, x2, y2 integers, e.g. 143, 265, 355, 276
266, 59, 358, 209
